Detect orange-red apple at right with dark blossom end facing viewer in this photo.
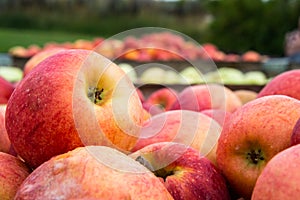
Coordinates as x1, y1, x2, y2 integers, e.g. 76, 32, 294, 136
217, 95, 300, 199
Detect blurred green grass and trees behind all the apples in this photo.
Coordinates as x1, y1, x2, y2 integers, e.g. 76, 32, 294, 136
0, 0, 300, 57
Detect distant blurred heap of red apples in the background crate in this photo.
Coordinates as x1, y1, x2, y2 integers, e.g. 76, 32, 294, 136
9, 31, 267, 62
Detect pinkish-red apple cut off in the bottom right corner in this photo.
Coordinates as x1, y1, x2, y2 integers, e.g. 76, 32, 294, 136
252, 144, 300, 200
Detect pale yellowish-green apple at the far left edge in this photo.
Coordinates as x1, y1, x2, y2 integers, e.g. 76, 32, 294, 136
0, 66, 23, 82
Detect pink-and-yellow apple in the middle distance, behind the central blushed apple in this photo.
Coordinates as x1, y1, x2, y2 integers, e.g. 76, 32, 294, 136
171, 84, 242, 112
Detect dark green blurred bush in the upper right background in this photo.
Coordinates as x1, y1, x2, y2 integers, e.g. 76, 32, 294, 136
207, 0, 300, 56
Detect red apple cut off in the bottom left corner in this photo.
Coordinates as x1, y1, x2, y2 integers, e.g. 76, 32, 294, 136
0, 152, 31, 200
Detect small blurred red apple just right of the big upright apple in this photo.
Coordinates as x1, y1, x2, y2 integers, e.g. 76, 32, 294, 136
146, 87, 178, 111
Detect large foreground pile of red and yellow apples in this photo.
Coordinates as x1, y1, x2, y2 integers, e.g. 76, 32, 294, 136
0, 49, 300, 200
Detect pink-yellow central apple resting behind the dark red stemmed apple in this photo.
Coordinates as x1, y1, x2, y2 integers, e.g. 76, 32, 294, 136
132, 110, 221, 163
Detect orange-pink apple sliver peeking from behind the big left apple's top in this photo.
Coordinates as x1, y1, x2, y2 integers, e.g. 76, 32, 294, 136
23, 47, 66, 76
